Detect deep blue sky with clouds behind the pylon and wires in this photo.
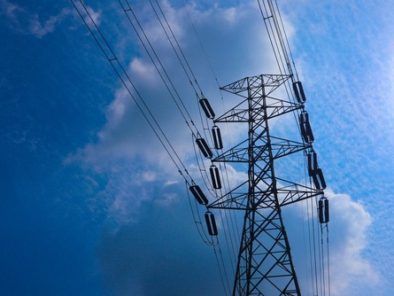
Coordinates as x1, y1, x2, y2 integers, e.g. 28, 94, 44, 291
0, 0, 394, 295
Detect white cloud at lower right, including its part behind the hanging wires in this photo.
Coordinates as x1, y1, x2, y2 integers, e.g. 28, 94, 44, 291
290, 188, 382, 296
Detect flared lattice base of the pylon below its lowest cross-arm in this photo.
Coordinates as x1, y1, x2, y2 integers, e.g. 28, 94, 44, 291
233, 209, 301, 296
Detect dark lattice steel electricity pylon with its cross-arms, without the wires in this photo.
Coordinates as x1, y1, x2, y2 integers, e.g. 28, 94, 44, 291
208, 74, 325, 296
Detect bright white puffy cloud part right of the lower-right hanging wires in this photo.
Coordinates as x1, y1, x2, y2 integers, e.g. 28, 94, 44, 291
327, 191, 379, 296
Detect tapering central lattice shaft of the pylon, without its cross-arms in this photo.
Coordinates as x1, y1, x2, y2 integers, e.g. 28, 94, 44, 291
233, 75, 300, 295
